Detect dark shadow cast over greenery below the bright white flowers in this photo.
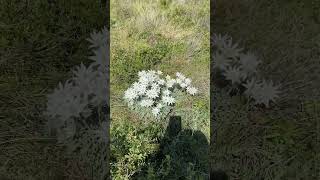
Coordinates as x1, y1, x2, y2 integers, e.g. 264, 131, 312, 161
132, 116, 209, 180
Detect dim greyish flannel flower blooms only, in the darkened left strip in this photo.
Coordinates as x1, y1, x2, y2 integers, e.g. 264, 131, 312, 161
45, 28, 109, 139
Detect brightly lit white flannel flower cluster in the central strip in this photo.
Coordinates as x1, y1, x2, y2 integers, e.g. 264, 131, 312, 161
124, 70, 198, 117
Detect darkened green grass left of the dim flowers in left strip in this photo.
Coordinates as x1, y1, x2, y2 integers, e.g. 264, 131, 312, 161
0, 0, 106, 180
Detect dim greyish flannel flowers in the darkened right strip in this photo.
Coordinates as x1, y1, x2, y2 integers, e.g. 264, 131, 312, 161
212, 34, 280, 107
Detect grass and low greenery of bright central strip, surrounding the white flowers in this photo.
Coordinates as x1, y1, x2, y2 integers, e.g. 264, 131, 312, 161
110, 0, 210, 179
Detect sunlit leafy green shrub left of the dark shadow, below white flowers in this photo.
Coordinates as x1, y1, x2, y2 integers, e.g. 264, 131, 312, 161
111, 120, 165, 179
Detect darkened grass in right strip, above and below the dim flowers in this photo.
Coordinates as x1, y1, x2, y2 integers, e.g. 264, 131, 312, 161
211, 0, 320, 180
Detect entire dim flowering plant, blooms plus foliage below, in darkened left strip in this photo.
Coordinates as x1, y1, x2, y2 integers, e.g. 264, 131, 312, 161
44, 28, 109, 179
